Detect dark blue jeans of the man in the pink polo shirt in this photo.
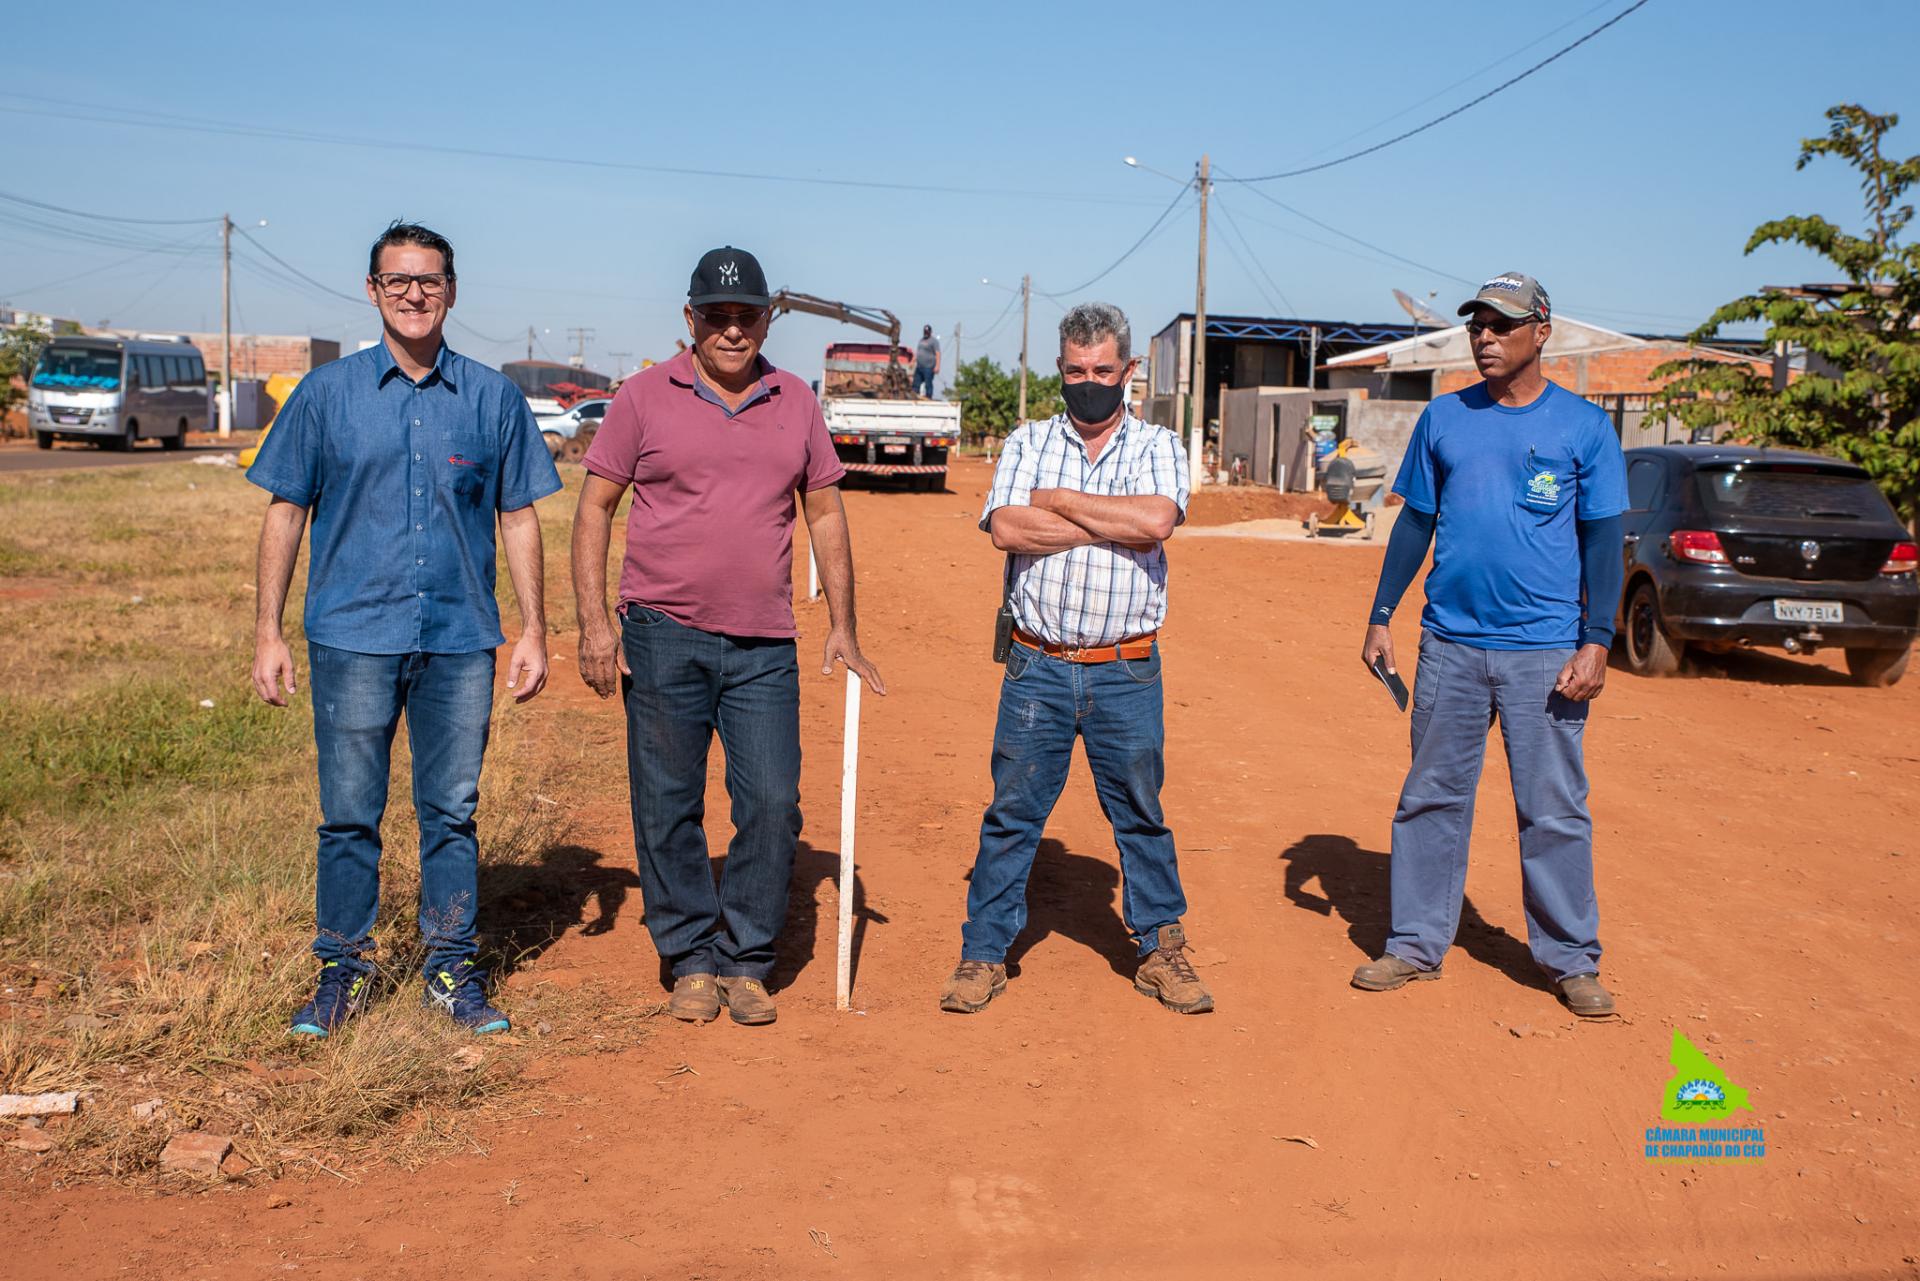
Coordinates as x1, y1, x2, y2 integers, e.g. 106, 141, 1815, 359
620, 605, 801, 981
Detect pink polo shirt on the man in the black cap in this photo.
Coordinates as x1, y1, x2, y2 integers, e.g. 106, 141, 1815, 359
586, 351, 847, 636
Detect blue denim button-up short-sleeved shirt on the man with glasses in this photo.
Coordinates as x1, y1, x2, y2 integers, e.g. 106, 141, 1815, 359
248, 342, 561, 653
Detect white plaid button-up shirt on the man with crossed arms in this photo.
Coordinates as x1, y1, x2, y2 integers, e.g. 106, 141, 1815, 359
979, 413, 1187, 645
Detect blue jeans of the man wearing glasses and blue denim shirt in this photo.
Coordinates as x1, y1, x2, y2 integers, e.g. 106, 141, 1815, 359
307, 641, 493, 974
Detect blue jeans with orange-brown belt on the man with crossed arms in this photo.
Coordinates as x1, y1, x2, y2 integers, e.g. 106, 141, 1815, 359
960, 643, 1187, 964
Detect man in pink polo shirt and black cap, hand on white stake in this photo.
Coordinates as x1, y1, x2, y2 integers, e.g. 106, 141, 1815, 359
574, 246, 887, 1024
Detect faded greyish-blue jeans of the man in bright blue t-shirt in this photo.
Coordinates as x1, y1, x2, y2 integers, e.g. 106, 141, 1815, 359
1386, 632, 1599, 979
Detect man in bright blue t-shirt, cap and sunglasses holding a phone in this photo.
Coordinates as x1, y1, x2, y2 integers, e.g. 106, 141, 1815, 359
1354, 273, 1626, 1018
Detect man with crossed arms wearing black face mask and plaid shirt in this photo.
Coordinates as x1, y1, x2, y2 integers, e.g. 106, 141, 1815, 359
941, 303, 1213, 1014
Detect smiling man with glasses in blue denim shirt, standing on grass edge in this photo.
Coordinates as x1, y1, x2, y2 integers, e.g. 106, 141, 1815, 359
248, 223, 561, 1037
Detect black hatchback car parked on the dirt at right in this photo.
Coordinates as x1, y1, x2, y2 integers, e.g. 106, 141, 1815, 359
1619, 446, 1920, 686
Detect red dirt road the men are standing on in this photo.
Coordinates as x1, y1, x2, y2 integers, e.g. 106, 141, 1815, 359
0, 463, 1920, 1281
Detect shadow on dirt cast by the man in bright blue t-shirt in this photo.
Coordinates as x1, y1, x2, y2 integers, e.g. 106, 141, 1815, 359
1281, 832, 1553, 991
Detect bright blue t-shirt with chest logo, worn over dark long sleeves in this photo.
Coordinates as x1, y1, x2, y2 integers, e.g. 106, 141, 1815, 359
1394, 382, 1626, 649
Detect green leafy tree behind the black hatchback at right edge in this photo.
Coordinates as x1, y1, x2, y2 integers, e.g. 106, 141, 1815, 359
1651, 104, 1920, 524
